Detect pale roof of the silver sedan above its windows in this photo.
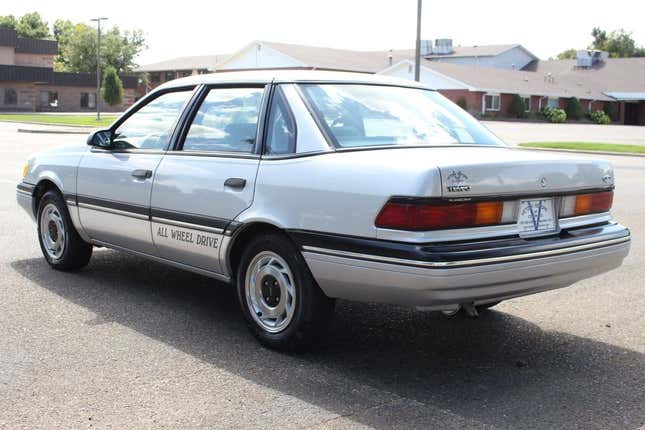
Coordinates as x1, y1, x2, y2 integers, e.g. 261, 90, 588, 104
158, 69, 431, 89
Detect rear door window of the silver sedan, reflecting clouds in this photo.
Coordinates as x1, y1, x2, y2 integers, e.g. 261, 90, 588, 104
183, 88, 264, 152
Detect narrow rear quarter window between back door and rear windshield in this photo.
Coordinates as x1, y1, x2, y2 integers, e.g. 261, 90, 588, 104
266, 87, 296, 155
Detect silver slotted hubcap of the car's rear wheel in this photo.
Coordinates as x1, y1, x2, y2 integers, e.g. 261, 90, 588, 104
244, 251, 296, 333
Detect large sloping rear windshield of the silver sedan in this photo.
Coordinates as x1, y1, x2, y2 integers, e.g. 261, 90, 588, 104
300, 84, 503, 148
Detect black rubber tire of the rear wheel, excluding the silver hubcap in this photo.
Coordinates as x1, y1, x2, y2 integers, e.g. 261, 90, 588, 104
237, 233, 334, 352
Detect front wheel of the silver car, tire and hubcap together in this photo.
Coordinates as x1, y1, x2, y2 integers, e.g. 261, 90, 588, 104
37, 191, 92, 270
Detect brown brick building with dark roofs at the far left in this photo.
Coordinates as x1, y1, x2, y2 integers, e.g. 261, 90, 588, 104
0, 29, 137, 112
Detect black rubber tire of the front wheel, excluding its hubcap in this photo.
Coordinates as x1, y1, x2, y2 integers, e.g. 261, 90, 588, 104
36, 191, 92, 271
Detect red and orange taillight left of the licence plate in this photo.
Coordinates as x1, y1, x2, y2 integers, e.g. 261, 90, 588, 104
375, 202, 504, 230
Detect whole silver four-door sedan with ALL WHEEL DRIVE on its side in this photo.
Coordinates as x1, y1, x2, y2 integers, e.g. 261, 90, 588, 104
17, 71, 630, 350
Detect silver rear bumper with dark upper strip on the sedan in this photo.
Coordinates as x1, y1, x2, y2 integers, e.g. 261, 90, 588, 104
300, 223, 630, 309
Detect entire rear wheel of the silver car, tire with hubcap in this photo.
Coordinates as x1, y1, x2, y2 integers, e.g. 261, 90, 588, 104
237, 233, 334, 351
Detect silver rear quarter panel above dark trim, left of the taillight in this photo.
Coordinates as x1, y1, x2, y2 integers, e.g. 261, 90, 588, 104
238, 150, 441, 237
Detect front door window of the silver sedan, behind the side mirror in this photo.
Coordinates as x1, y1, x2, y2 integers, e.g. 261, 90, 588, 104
113, 89, 192, 149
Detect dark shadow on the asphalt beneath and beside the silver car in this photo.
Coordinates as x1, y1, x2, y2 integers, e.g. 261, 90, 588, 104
12, 251, 645, 428
